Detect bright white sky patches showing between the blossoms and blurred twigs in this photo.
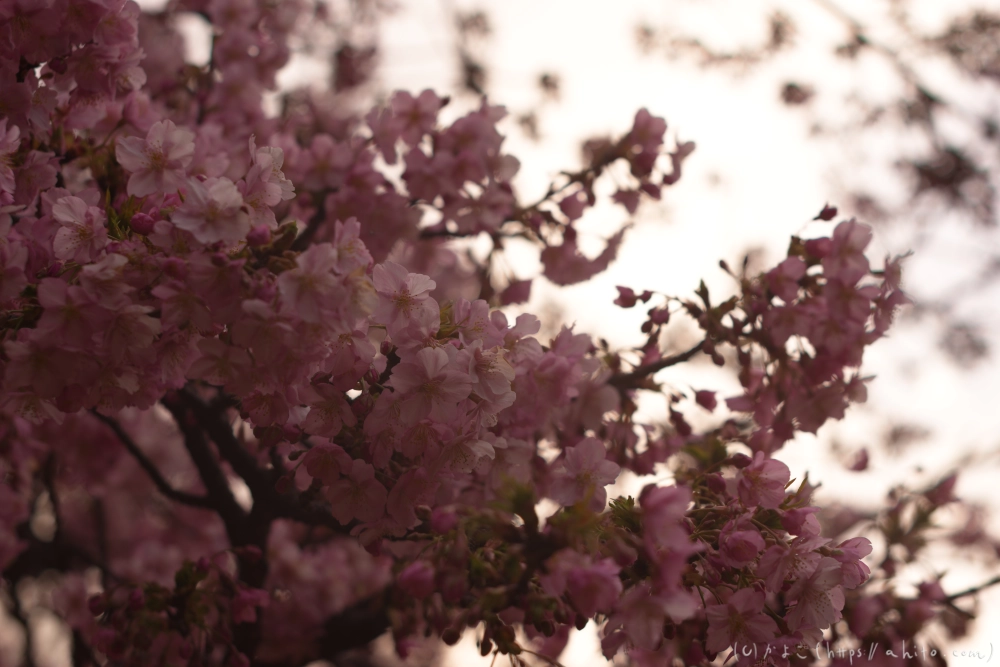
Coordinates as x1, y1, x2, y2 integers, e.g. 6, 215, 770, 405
60, 0, 1000, 667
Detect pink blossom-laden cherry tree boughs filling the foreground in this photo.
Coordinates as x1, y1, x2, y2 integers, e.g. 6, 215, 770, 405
0, 0, 984, 666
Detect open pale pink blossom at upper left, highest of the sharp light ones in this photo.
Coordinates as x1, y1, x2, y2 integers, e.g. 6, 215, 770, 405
115, 120, 194, 197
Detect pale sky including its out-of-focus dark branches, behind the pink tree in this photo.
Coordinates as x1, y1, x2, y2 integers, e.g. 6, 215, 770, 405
15, 0, 1000, 666
